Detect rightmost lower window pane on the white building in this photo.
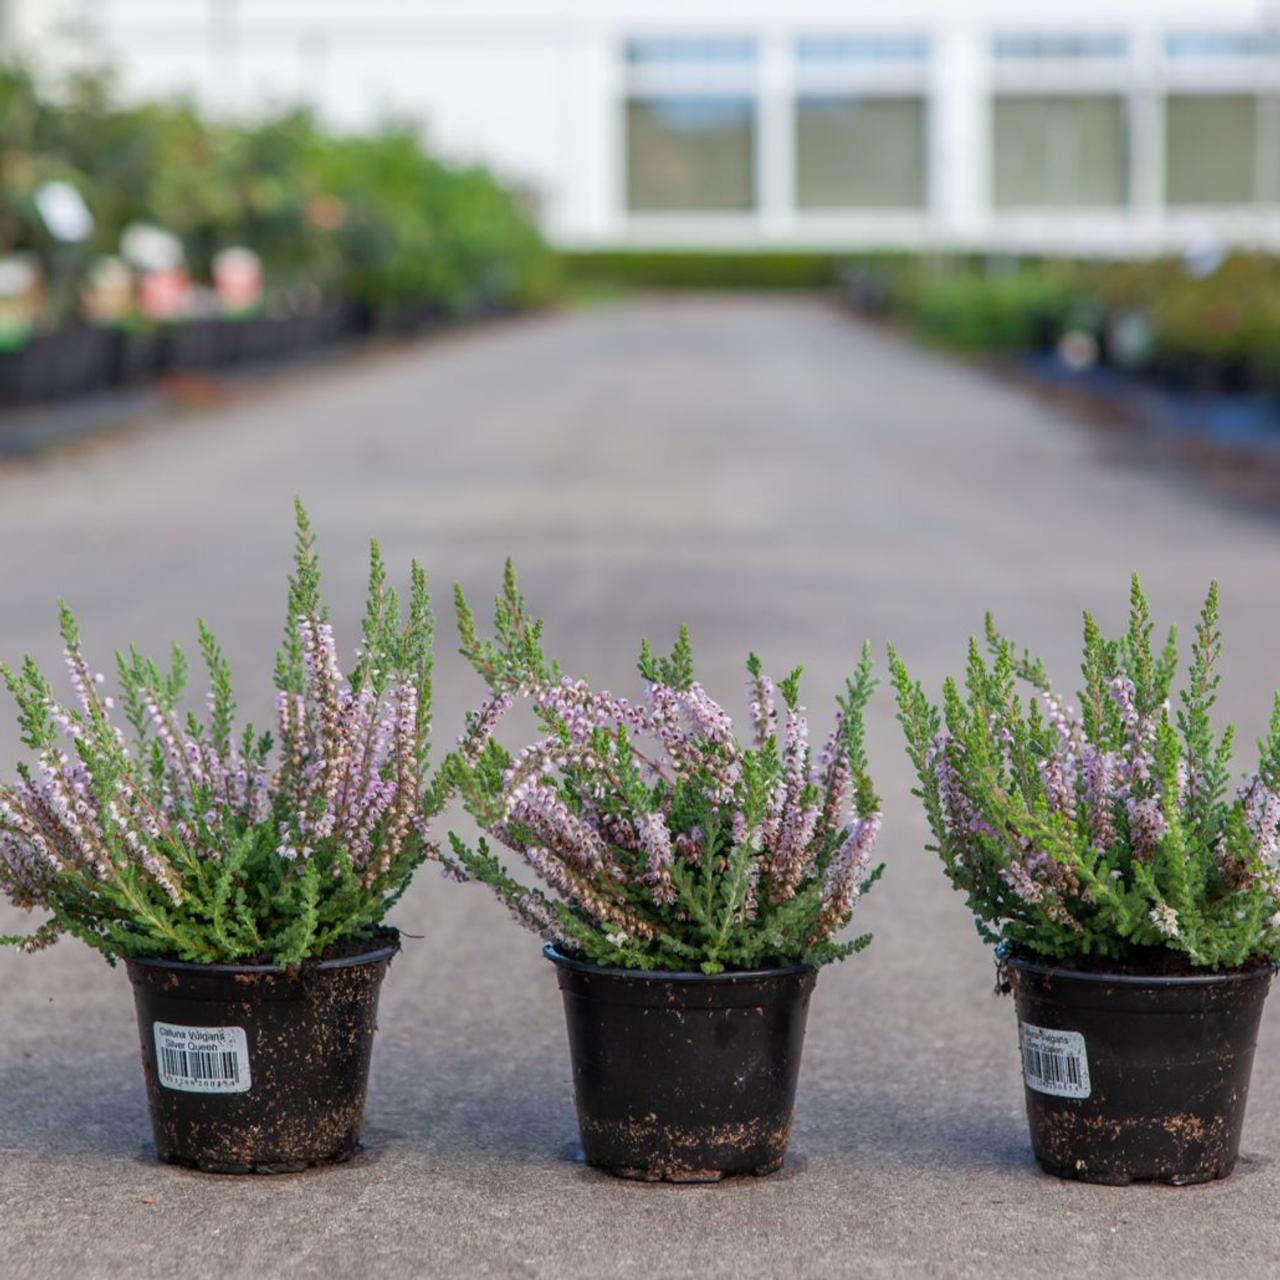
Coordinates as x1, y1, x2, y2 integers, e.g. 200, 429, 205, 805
1165, 93, 1258, 205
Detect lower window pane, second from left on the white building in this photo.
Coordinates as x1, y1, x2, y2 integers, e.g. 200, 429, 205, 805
796, 96, 924, 209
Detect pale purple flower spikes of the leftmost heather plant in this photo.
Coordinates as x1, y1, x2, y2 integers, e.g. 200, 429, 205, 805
0, 621, 432, 926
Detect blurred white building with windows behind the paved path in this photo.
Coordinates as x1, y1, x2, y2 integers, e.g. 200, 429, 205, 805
4, 0, 1280, 253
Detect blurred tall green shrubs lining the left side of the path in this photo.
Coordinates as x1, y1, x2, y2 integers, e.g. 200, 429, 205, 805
0, 68, 556, 350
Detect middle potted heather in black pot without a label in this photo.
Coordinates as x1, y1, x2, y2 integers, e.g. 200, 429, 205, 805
443, 564, 881, 1181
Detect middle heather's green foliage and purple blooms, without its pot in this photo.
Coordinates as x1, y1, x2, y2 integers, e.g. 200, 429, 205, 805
444, 564, 879, 973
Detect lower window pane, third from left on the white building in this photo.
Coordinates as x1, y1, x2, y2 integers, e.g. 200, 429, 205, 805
993, 93, 1129, 209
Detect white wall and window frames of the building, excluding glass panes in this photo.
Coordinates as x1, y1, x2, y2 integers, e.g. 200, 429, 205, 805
9, 0, 1280, 252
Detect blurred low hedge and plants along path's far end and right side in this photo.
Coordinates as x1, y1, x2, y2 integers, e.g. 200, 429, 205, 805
566, 250, 1280, 390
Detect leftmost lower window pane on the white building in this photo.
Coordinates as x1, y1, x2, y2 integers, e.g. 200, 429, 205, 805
627, 97, 755, 210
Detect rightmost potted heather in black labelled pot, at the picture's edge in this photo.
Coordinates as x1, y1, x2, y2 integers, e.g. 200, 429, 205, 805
890, 577, 1280, 1183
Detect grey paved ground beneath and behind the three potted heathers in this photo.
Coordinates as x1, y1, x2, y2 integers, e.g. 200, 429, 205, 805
0, 298, 1280, 1280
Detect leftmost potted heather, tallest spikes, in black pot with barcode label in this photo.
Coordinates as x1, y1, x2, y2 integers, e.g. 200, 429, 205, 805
0, 506, 434, 1172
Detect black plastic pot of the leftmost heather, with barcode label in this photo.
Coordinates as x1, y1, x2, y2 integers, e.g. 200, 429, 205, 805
125, 929, 399, 1174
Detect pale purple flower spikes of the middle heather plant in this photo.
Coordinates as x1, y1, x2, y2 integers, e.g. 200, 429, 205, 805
460, 676, 879, 946
